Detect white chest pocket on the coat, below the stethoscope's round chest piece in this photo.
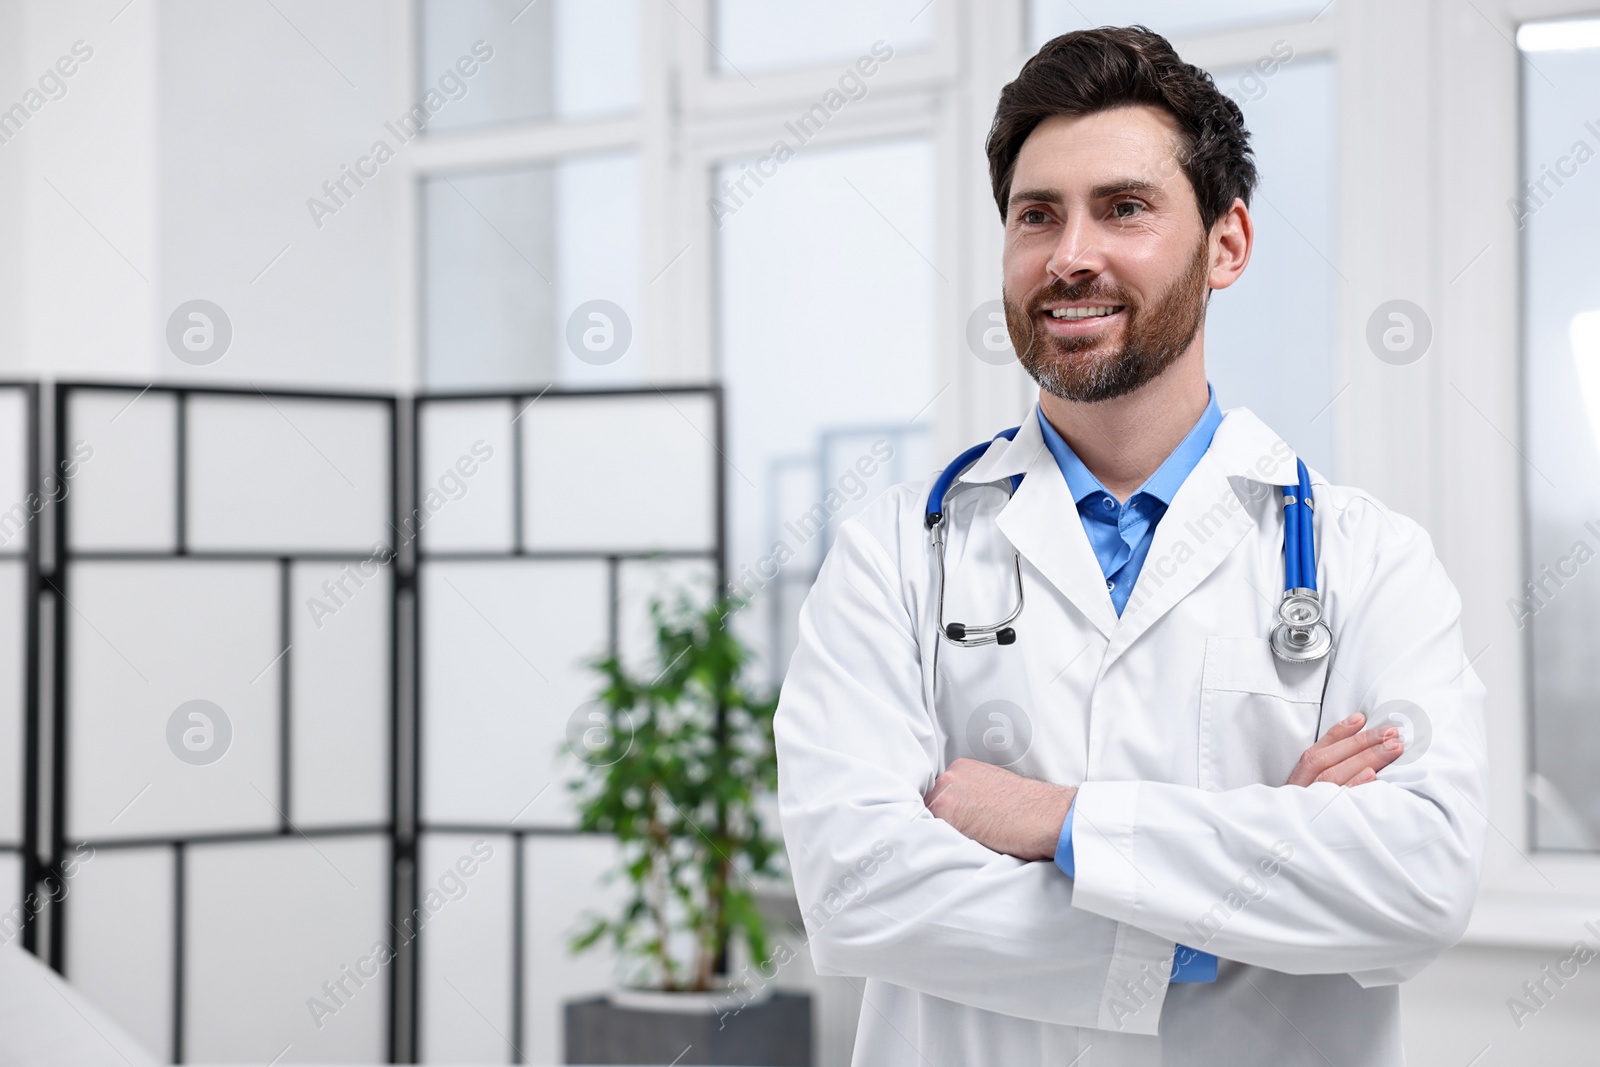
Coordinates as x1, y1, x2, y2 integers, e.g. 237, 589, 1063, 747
1198, 637, 1328, 792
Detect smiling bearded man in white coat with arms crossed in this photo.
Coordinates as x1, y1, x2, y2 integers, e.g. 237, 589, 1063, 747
778, 29, 1486, 1067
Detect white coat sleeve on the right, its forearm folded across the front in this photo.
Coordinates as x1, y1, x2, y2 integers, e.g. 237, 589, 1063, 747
1072, 498, 1488, 985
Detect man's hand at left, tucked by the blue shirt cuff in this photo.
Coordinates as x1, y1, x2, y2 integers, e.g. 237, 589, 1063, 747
923, 758, 1078, 861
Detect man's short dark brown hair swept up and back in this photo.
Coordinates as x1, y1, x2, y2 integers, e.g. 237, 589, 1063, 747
986, 26, 1256, 230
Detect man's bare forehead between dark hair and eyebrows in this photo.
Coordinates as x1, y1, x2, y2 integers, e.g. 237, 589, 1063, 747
1011, 104, 1187, 192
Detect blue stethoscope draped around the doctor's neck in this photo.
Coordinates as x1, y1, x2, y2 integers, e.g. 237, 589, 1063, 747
923, 426, 1333, 662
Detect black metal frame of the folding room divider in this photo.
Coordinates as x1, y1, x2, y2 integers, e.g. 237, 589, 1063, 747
10, 381, 728, 1062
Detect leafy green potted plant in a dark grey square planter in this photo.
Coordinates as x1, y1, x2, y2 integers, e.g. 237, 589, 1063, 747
565, 595, 811, 1065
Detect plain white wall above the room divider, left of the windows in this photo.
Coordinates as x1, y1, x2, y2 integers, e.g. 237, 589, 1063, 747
0, 0, 411, 389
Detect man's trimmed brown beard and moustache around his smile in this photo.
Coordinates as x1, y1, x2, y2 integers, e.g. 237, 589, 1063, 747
1003, 237, 1210, 403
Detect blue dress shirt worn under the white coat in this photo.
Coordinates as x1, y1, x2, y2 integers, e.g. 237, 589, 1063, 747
1038, 386, 1222, 982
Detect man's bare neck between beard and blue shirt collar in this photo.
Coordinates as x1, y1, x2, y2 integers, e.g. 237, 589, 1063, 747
1038, 347, 1210, 501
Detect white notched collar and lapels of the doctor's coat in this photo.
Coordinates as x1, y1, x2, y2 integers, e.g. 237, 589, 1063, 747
960, 405, 1296, 646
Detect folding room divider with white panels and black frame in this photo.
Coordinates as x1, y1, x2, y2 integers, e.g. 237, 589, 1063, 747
0, 382, 725, 1062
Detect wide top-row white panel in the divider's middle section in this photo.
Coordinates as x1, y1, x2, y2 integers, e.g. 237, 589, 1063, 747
187, 395, 392, 550
